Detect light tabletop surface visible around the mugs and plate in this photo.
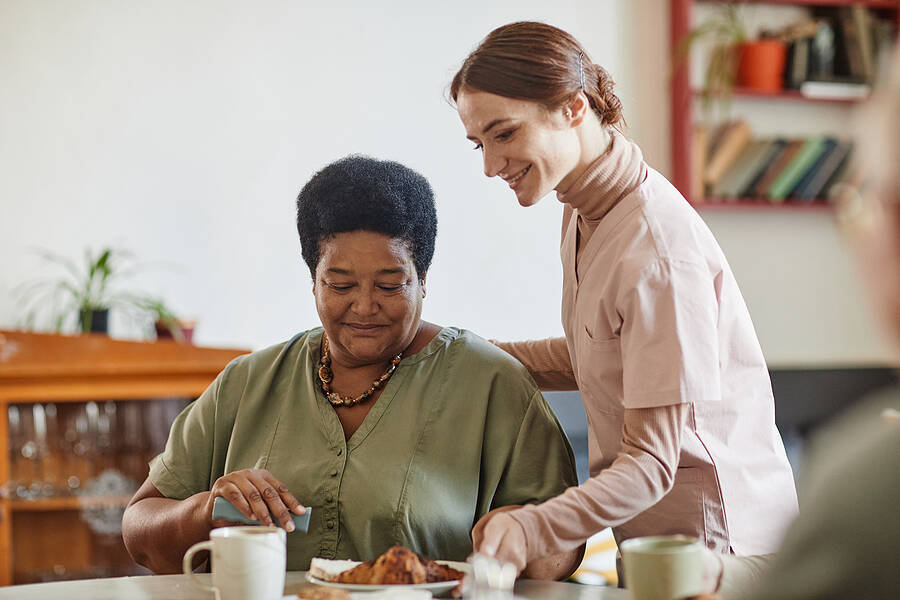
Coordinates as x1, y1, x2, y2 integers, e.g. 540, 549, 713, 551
0, 571, 628, 600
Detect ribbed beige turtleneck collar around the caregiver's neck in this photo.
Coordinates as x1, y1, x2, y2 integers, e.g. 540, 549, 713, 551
556, 129, 647, 225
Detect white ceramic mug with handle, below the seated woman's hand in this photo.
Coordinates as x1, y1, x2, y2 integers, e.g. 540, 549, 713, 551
182, 526, 287, 600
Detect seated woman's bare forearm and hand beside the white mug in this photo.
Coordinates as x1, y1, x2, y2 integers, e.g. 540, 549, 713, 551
122, 469, 306, 574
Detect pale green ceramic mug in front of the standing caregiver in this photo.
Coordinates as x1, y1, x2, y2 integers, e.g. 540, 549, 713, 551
621, 535, 703, 600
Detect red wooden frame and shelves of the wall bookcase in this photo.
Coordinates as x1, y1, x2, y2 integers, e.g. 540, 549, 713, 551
670, 0, 900, 210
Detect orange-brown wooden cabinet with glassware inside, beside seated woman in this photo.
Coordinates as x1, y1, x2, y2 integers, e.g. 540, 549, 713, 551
0, 331, 246, 585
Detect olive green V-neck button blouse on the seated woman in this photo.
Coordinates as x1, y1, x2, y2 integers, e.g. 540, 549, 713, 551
150, 327, 577, 570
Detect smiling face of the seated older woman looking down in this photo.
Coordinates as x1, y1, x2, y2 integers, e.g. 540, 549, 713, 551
313, 231, 425, 367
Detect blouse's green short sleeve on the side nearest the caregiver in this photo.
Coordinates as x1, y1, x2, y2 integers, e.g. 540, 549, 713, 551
491, 391, 578, 509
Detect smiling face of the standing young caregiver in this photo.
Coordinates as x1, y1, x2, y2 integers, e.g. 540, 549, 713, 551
456, 88, 580, 206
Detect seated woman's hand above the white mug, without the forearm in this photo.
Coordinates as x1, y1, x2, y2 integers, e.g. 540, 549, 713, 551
205, 469, 306, 532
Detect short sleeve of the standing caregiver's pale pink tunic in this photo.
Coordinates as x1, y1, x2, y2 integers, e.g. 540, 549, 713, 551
617, 260, 721, 408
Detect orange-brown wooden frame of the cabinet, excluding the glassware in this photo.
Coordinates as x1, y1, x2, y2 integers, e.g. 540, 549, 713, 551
0, 331, 246, 585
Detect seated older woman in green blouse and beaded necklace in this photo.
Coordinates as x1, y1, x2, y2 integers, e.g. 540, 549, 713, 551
123, 156, 581, 578
